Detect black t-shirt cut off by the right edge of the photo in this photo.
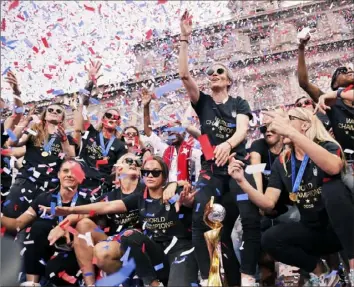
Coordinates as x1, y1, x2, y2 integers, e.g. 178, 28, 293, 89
327, 99, 354, 160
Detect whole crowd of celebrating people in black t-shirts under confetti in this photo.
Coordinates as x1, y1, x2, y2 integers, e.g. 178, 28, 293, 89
1, 12, 354, 287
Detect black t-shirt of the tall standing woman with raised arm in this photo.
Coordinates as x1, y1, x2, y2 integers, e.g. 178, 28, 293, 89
192, 91, 252, 168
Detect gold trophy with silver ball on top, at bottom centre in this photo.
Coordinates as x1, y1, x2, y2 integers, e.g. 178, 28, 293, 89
203, 196, 226, 286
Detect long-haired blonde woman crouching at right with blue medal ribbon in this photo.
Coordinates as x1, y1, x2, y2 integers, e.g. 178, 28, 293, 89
229, 108, 354, 286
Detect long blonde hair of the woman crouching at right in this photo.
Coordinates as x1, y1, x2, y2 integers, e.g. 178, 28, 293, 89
279, 108, 346, 172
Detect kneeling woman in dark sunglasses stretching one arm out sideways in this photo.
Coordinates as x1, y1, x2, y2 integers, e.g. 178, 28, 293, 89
56, 156, 198, 286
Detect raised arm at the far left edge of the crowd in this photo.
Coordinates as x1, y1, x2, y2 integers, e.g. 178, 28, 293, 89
4, 71, 24, 130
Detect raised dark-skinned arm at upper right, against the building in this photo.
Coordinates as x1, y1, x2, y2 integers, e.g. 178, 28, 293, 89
297, 38, 323, 103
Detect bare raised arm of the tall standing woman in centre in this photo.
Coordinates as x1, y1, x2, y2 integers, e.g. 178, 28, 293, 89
178, 11, 199, 104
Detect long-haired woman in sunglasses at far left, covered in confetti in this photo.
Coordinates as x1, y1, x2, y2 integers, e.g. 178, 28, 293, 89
3, 104, 75, 218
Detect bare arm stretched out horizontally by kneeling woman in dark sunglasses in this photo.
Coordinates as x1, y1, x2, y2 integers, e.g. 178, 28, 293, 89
55, 200, 127, 216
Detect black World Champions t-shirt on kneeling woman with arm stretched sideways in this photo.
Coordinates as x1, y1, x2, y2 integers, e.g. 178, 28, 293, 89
123, 189, 192, 242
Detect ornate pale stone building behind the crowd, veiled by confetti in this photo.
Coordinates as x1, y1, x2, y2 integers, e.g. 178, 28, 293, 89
13, 0, 354, 140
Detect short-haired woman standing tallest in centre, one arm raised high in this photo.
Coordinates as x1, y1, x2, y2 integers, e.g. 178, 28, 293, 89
179, 12, 261, 286
